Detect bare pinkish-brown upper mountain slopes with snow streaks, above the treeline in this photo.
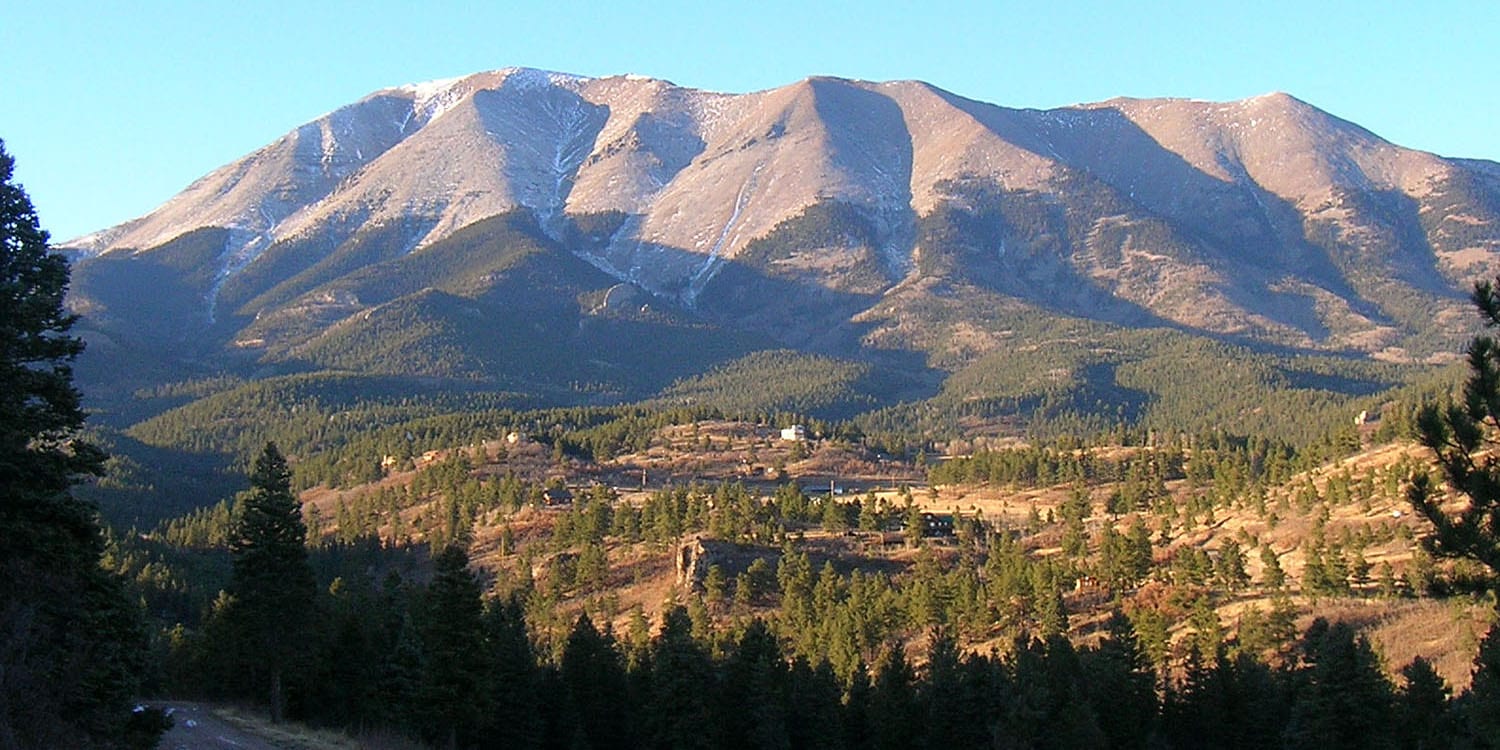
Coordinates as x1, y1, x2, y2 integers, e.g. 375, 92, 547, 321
66, 69, 1500, 357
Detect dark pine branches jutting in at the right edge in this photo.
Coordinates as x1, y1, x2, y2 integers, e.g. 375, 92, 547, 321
1407, 279, 1500, 576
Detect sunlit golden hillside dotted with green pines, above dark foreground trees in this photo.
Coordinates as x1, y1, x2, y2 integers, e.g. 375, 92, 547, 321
128, 420, 1491, 699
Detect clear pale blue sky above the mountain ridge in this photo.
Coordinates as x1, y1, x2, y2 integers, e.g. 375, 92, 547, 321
0, 0, 1500, 240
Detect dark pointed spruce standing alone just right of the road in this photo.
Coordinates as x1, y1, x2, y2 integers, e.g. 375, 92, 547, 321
228, 443, 317, 722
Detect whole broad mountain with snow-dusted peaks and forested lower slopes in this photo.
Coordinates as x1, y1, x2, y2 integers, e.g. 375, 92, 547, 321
62, 69, 1500, 444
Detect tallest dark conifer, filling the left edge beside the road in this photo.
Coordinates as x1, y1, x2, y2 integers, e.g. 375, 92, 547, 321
0, 141, 155, 747
